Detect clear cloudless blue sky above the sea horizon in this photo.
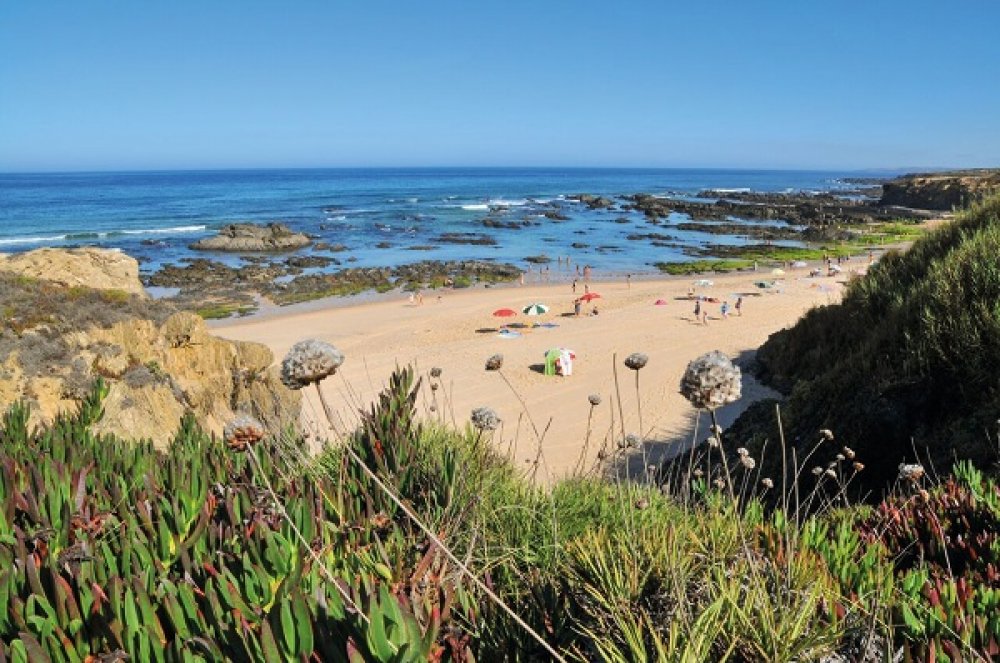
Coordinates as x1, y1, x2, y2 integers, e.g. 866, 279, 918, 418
0, 0, 1000, 171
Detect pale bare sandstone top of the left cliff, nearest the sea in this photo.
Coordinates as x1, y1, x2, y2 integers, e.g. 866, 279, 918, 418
0, 248, 147, 297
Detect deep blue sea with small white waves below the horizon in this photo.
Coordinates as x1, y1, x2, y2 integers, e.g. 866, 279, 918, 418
0, 168, 876, 272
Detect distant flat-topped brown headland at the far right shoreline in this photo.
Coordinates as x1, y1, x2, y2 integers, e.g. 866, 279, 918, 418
879, 170, 1000, 210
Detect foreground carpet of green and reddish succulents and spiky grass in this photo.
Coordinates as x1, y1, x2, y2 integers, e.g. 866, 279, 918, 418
0, 370, 1000, 663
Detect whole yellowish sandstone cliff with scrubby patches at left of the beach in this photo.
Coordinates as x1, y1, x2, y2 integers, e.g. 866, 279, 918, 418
0, 249, 299, 446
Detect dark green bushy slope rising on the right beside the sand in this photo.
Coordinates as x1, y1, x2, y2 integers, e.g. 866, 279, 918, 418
733, 198, 1000, 487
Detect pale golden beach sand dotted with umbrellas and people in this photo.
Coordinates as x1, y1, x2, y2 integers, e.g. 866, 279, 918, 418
213, 260, 852, 481
